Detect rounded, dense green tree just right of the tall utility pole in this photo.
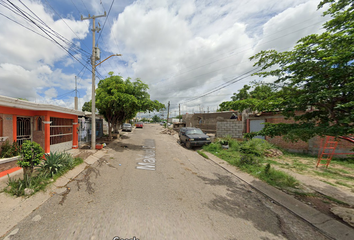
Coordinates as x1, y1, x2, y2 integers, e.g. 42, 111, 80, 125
96, 72, 165, 137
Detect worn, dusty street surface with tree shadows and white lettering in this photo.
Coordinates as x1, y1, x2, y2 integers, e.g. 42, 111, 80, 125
5, 124, 327, 240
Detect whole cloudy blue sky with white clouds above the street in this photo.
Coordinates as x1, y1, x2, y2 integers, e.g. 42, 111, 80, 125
0, 0, 326, 116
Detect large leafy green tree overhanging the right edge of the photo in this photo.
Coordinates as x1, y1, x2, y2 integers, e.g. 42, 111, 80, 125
246, 0, 354, 141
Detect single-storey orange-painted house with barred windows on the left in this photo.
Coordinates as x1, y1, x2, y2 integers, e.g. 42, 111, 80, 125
0, 96, 84, 175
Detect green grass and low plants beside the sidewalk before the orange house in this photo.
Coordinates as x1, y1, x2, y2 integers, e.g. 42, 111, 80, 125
3, 157, 84, 196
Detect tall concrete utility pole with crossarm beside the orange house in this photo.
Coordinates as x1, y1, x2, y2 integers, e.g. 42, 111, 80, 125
81, 11, 106, 149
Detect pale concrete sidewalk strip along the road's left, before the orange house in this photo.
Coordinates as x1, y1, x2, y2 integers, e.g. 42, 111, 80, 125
0, 150, 106, 238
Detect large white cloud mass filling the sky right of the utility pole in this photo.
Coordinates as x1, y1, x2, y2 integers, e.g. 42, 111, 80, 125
107, 0, 323, 115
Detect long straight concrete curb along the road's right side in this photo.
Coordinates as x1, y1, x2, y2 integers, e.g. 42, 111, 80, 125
204, 152, 354, 240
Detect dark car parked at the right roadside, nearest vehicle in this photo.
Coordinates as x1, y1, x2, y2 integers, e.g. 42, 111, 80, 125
178, 127, 211, 149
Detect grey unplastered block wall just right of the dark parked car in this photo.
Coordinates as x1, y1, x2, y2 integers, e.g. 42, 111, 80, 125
216, 119, 243, 138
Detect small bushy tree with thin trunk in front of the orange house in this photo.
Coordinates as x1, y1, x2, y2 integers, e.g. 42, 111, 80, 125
17, 140, 44, 184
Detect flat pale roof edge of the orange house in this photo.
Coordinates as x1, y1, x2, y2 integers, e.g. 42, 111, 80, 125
0, 96, 84, 116
